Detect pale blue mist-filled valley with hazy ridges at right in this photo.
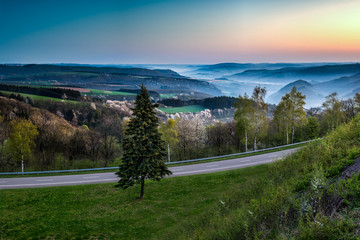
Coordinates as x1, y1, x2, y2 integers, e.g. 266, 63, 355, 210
139, 63, 360, 107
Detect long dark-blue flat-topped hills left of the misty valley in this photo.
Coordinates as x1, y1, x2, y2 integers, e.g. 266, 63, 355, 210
0, 64, 221, 96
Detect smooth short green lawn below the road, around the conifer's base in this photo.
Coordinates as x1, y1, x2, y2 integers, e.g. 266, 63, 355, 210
0, 165, 268, 239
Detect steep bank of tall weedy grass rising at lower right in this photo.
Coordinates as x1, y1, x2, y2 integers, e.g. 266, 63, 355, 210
192, 118, 360, 239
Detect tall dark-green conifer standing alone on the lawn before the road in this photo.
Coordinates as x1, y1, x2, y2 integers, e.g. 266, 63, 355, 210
116, 85, 171, 199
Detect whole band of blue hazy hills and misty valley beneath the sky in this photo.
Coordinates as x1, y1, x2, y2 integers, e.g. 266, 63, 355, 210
0, 63, 360, 108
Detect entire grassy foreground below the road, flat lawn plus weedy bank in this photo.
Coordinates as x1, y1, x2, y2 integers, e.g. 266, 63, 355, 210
0, 119, 360, 239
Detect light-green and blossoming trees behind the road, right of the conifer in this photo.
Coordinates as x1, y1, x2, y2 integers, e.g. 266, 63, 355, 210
159, 87, 360, 161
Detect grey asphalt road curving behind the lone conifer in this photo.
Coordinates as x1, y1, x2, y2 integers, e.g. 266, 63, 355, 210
0, 148, 299, 189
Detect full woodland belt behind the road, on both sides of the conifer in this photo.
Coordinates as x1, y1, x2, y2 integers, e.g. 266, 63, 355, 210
0, 88, 360, 171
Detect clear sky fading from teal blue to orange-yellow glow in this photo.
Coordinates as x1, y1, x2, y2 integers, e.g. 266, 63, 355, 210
0, 0, 360, 64
